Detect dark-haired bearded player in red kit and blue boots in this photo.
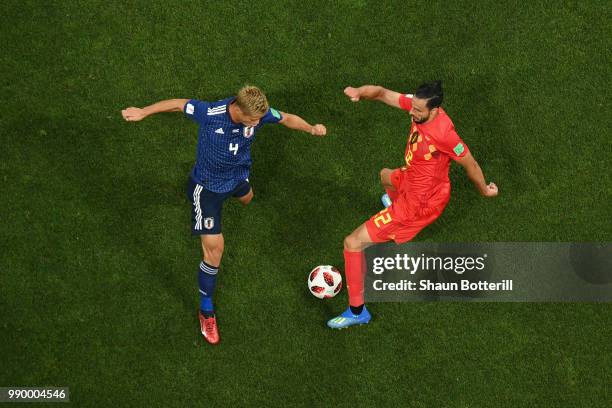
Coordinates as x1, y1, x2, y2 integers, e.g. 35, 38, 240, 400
327, 81, 498, 329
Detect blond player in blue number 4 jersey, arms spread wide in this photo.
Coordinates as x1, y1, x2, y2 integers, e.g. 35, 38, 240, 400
121, 86, 327, 344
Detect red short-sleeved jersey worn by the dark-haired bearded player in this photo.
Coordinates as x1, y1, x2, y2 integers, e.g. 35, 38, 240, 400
399, 95, 469, 204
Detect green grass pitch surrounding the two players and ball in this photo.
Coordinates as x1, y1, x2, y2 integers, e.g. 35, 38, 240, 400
0, 0, 612, 408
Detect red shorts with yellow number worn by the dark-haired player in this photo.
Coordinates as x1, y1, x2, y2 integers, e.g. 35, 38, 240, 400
365, 171, 450, 244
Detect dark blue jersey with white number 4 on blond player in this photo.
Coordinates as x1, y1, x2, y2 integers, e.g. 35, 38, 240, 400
184, 97, 282, 193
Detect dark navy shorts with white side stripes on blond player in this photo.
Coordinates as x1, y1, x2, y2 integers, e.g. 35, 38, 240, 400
187, 177, 251, 235
